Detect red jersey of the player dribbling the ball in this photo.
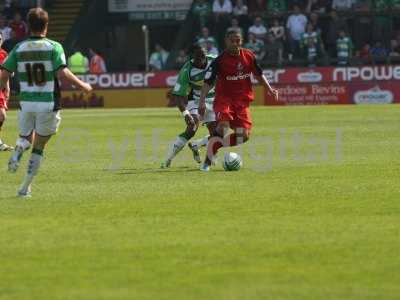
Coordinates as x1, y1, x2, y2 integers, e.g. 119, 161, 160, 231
205, 48, 262, 103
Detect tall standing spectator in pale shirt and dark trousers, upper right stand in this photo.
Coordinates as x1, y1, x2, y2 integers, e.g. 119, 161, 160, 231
286, 4, 307, 60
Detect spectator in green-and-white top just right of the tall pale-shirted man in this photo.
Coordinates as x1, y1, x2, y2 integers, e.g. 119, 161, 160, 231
300, 23, 323, 64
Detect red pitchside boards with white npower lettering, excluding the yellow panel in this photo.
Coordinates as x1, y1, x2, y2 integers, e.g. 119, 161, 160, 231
61, 65, 400, 105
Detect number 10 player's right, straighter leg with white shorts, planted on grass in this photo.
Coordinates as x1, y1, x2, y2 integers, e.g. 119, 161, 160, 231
18, 112, 61, 197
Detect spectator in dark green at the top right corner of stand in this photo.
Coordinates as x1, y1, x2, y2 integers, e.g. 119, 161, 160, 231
372, 0, 393, 47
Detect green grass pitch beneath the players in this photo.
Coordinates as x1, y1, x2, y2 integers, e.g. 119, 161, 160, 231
0, 105, 400, 300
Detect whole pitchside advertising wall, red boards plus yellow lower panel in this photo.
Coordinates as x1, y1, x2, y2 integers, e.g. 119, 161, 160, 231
58, 66, 400, 108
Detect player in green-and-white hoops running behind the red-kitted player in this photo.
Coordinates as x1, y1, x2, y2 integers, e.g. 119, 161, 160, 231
161, 45, 216, 168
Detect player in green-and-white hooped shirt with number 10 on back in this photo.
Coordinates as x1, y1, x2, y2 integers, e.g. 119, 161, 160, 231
0, 8, 92, 197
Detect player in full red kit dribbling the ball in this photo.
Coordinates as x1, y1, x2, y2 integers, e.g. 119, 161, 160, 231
199, 31, 278, 171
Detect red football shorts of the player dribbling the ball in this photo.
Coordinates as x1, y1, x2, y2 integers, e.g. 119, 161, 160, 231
214, 99, 253, 130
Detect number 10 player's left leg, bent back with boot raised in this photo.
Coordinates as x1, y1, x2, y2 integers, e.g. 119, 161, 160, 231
8, 111, 35, 173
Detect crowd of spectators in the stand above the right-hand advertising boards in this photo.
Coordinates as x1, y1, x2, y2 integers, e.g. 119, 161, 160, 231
168, 0, 400, 68
